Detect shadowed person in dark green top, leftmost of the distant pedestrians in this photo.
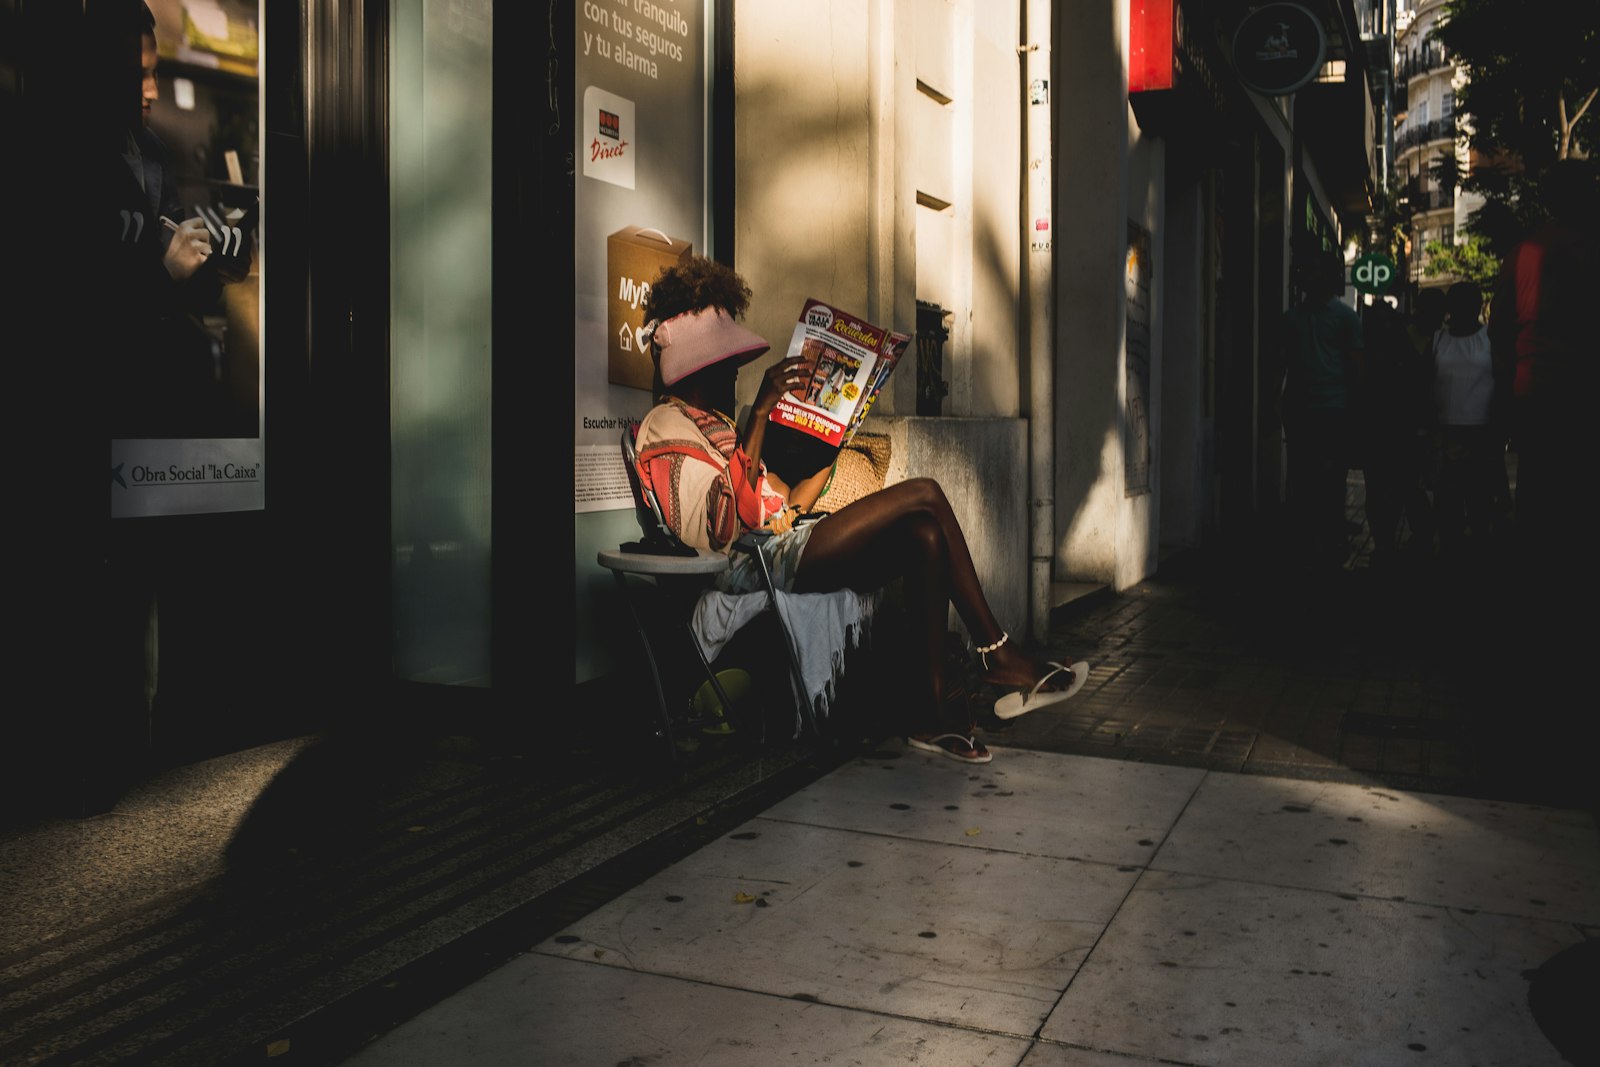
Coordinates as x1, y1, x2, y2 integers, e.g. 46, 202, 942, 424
1282, 253, 1363, 561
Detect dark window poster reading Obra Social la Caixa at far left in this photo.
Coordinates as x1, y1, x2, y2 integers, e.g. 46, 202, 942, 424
108, 0, 266, 518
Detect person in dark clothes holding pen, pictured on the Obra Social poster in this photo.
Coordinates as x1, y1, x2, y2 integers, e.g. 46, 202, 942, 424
99, 3, 222, 437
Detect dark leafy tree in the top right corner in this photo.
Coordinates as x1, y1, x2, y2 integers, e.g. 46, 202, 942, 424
1434, 0, 1600, 251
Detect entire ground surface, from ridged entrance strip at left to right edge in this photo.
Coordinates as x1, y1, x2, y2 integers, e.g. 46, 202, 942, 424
0, 527, 1600, 1067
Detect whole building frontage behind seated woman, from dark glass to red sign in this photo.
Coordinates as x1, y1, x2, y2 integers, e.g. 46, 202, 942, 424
0, 0, 1374, 799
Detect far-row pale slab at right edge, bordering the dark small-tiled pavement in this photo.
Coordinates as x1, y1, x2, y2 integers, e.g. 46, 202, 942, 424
1150, 774, 1600, 925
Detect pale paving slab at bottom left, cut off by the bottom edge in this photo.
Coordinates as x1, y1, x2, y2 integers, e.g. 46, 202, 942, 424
344, 953, 1030, 1067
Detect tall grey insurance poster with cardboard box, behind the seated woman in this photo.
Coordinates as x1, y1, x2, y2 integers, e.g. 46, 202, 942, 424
573, 0, 710, 514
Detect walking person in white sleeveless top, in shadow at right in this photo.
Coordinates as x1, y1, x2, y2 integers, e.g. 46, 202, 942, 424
1434, 282, 1506, 555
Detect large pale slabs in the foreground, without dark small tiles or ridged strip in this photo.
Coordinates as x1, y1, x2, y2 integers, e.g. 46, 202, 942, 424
337, 742, 1600, 1067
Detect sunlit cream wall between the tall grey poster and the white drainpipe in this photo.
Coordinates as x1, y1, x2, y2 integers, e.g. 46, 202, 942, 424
734, 0, 1029, 632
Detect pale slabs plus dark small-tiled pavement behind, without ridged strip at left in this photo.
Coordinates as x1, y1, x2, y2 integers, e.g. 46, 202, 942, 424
334, 511, 1600, 1067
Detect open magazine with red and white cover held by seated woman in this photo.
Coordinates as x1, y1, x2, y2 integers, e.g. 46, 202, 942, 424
771, 299, 910, 451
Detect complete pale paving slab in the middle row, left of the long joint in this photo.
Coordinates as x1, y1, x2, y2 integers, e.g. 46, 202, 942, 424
538, 819, 1139, 1035
